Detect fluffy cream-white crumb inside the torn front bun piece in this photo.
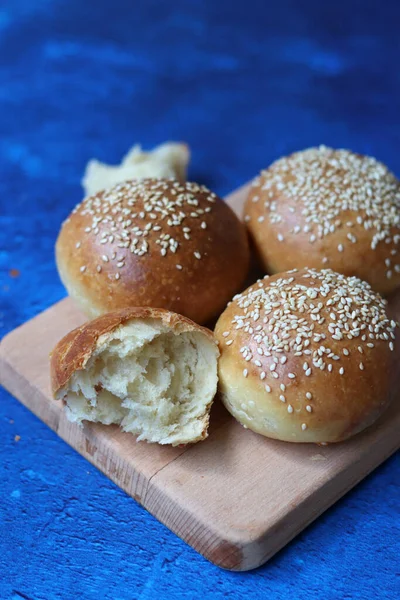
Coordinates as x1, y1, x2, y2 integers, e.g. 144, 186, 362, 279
62, 319, 217, 444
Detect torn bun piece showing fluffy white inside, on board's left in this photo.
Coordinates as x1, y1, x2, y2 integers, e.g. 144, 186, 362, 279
51, 308, 219, 446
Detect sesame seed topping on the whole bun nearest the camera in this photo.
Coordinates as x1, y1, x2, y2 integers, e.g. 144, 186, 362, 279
231, 269, 396, 400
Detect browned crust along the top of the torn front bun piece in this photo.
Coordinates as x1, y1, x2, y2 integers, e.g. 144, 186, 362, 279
50, 307, 218, 397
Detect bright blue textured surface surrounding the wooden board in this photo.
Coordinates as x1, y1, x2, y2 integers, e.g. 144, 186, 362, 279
0, 0, 400, 600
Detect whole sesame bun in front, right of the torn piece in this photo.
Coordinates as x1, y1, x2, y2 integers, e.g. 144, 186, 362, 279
215, 269, 398, 443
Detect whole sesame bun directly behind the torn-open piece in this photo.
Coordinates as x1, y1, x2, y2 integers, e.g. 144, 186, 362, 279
56, 179, 249, 323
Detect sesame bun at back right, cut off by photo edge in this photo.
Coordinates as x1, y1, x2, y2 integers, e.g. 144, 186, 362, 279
244, 146, 400, 294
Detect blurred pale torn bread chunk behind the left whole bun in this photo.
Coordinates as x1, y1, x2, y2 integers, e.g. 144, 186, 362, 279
82, 142, 190, 196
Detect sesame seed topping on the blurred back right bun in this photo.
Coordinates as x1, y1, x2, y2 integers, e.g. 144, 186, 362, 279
253, 146, 400, 264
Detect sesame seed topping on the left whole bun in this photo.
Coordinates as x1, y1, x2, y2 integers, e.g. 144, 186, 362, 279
75, 179, 217, 268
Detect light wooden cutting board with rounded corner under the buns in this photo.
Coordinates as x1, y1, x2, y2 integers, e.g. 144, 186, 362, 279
0, 186, 400, 571
